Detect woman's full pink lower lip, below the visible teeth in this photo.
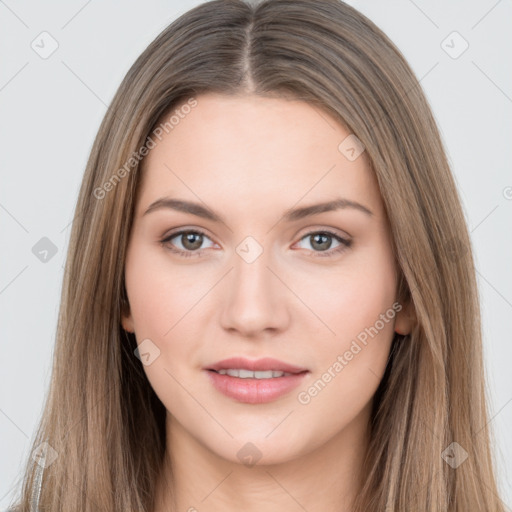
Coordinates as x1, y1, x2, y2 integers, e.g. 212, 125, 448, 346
206, 370, 308, 404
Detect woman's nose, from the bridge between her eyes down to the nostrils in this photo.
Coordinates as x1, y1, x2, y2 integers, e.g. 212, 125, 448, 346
222, 237, 287, 334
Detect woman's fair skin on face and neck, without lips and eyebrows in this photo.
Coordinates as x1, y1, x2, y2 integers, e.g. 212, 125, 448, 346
122, 94, 412, 512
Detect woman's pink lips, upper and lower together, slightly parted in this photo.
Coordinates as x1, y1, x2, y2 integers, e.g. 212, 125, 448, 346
204, 357, 309, 404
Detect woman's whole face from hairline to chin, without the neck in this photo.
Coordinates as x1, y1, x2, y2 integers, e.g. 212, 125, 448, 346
123, 94, 410, 463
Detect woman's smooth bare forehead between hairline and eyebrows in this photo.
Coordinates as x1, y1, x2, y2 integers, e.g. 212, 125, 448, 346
138, 93, 382, 220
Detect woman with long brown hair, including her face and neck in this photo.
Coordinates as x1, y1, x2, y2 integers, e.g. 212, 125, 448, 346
7, 0, 504, 512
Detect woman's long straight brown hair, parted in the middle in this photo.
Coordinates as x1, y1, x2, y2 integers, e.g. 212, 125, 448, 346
8, 0, 504, 512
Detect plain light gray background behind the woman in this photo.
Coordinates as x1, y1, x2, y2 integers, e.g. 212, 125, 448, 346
0, 0, 512, 509
